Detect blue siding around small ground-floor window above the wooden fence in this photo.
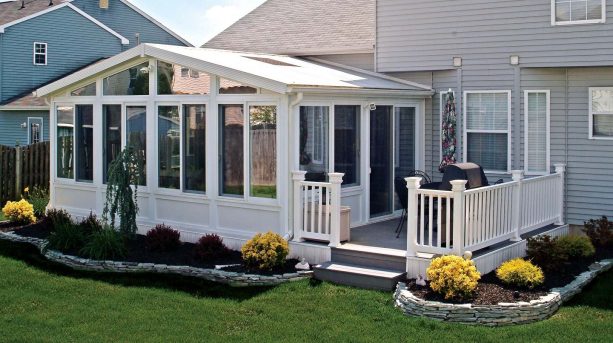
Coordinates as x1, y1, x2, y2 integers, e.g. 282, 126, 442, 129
0, 111, 49, 146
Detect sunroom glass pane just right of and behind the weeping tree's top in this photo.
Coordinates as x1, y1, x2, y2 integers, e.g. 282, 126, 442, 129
126, 106, 147, 186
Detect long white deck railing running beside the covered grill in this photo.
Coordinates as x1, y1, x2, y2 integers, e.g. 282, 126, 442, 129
406, 164, 565, 256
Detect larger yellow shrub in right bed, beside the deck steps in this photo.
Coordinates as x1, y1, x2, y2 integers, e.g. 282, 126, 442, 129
426, 255, 481, 300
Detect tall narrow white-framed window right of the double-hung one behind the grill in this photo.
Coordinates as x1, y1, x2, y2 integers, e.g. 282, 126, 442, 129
524, 91, 550, 174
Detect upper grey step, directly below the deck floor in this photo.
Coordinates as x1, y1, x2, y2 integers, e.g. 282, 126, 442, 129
331, 244, 407, 272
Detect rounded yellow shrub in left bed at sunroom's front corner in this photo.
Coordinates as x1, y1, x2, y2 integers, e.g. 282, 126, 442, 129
241, 232, 289, 270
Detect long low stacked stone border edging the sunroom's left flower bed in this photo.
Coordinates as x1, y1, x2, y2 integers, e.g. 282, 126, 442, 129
0, 232, 313, 287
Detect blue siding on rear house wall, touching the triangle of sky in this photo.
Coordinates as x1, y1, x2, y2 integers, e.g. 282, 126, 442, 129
72, 0, 185, 47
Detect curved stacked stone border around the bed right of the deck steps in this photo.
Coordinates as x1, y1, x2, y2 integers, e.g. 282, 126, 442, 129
394, 259, 613, 326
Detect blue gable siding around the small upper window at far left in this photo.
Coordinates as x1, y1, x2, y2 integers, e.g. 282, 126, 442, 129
0, 7, 123, 101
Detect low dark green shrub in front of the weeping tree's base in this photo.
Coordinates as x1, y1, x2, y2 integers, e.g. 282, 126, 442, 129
81, 226, 126, 260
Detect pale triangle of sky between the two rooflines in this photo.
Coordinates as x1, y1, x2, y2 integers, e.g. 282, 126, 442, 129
130, 0, 266, 46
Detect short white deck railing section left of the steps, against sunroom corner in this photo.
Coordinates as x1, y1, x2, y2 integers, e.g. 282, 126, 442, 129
292, 171, 345, 247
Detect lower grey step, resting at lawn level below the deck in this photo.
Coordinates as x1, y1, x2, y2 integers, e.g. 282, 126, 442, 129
313, 261, 406, 291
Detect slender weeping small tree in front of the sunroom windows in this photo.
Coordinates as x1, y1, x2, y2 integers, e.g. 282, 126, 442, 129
102, 147, 142, 235
